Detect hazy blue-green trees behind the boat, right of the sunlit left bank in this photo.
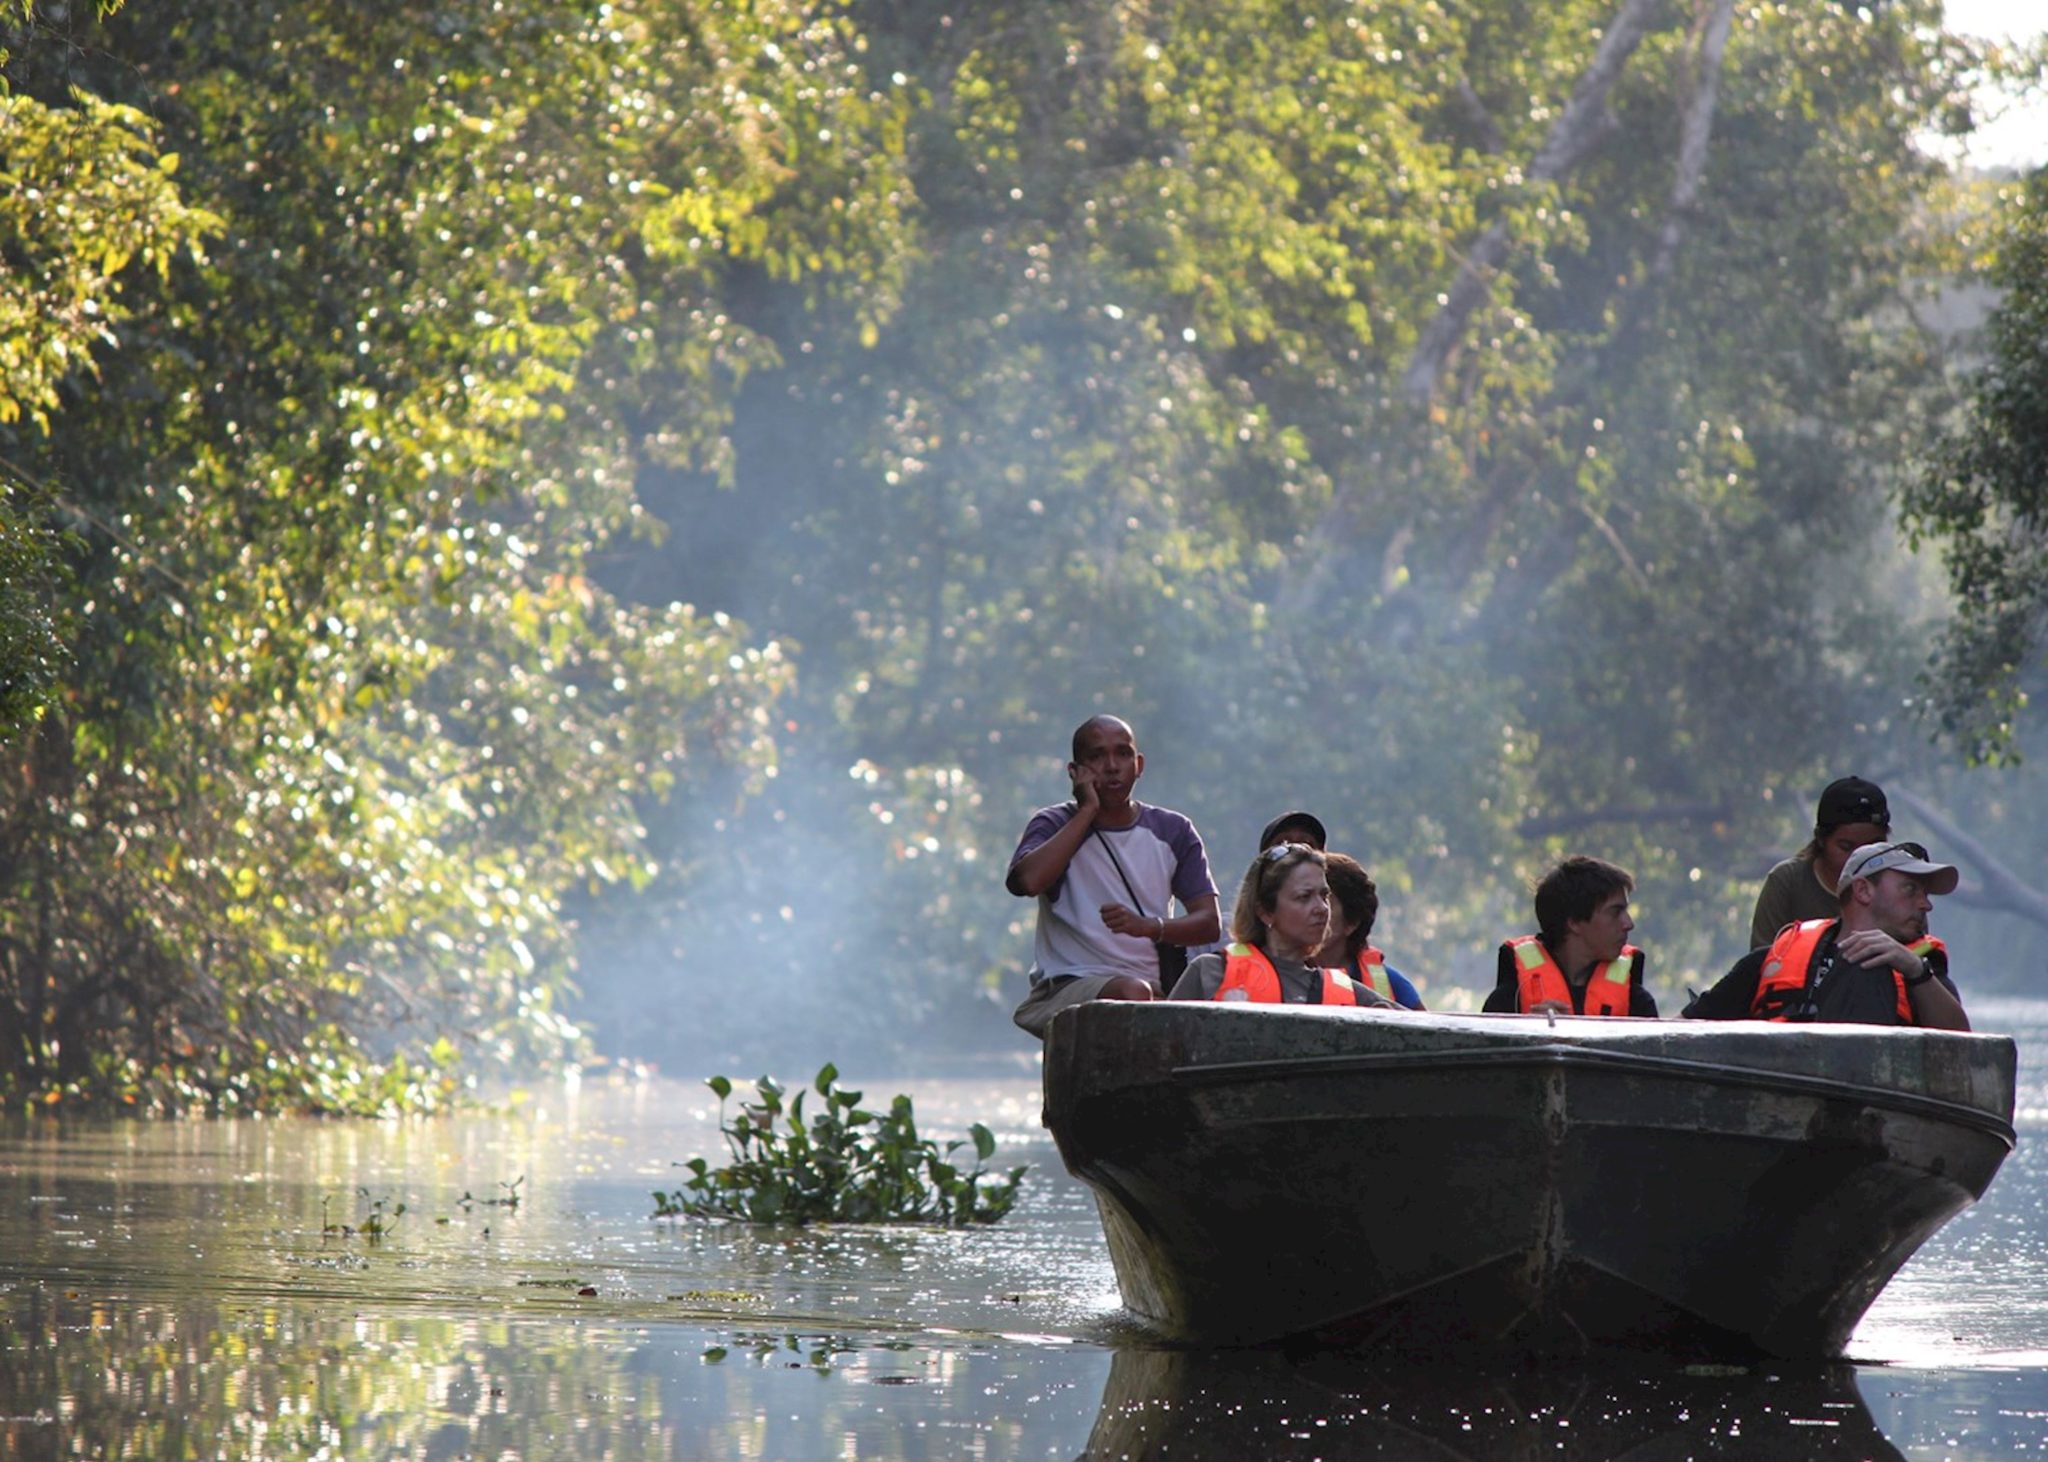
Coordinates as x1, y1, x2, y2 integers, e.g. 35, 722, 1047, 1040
606, 4, 2015, 1072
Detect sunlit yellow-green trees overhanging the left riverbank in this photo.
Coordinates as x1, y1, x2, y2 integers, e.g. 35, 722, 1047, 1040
0, 2, 901, 1108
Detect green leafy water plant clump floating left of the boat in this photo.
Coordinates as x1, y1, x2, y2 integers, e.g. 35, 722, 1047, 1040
653, 1063, 1028, 1227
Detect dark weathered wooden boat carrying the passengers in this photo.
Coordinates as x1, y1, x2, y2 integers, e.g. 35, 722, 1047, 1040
1044, 1001, 2015, 1358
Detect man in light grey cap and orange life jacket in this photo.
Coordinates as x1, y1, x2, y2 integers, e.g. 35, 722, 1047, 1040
1686, 842, 1970, 1030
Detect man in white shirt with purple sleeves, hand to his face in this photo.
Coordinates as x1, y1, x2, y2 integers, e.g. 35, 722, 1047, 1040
1006, 717, 1223, 1040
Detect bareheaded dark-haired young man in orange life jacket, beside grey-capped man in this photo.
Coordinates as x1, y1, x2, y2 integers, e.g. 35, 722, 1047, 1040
1485, 856, 1657, 1020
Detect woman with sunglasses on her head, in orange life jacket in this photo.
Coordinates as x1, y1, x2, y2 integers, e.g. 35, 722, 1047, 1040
1167, 844, 1395, 1005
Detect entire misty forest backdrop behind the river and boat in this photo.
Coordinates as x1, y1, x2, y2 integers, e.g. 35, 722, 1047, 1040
0, 0, 2048, 1110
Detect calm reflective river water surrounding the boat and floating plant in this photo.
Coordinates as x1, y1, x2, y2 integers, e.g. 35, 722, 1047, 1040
0, 1003, 2048, 1458
